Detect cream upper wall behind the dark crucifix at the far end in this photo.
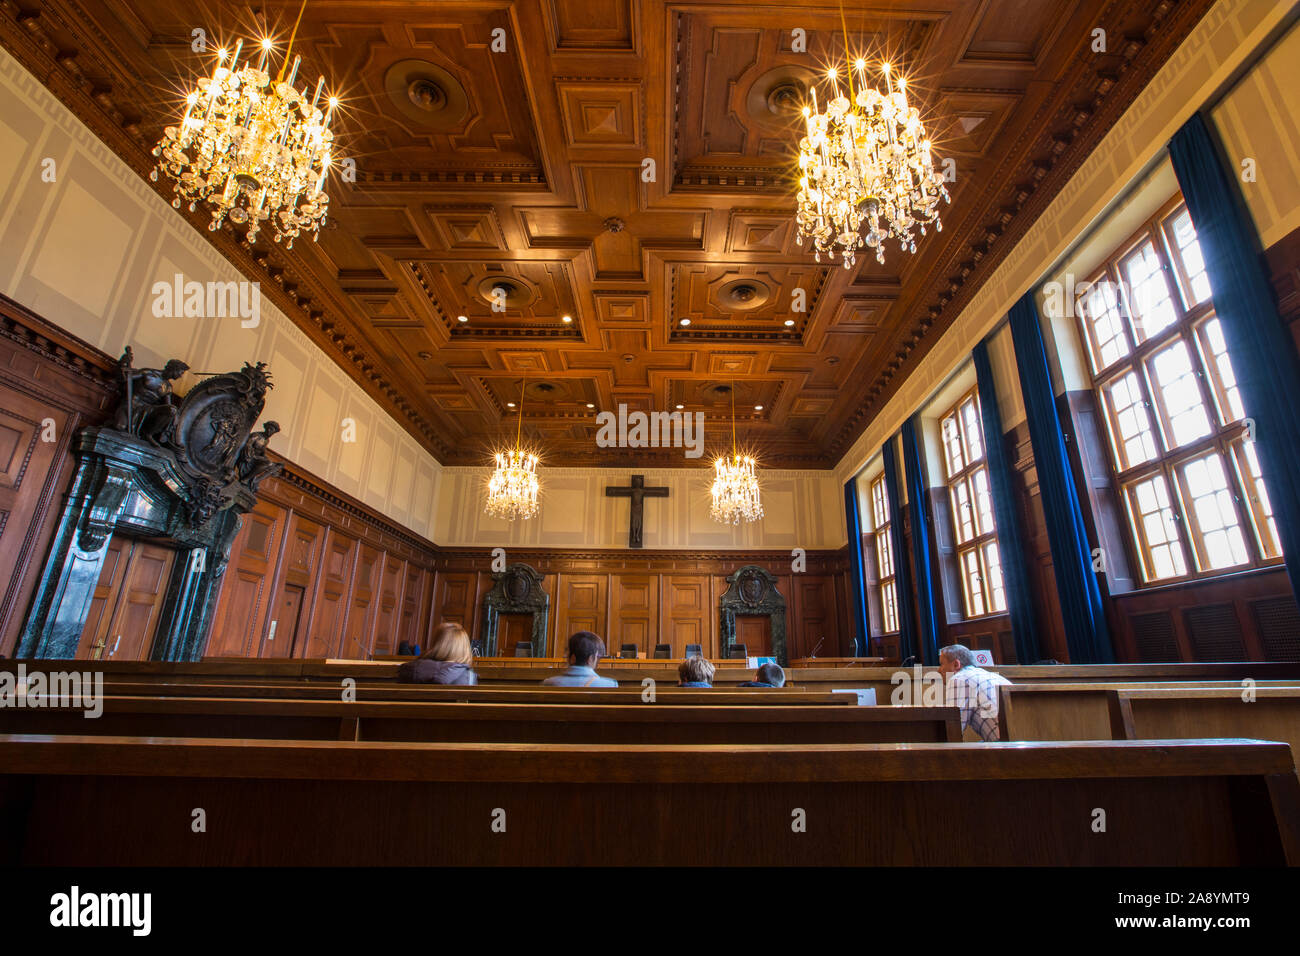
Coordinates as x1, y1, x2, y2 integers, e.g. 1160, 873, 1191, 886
436, 464, 848, 550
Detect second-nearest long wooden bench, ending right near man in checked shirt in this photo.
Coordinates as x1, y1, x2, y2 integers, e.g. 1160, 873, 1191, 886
0, 697, 961, 744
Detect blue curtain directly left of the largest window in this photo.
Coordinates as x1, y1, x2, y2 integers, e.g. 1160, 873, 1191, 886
1008, 290, 1115, 663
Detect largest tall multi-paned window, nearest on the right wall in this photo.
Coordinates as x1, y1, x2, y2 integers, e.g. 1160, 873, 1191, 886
1076, 198, 1282, 583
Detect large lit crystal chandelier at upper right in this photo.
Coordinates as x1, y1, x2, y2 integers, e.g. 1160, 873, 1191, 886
796, 59, 948, 269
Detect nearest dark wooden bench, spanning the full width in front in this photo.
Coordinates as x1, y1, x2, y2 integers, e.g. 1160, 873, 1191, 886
0, 735, 1300, 866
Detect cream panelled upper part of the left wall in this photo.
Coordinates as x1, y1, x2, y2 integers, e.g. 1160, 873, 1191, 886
0, 49, 441, 538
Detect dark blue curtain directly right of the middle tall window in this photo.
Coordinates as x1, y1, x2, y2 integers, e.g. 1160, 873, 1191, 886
971, 339, 1043, 663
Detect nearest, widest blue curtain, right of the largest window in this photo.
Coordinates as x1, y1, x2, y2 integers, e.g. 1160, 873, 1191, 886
1169, 113, 1300, 600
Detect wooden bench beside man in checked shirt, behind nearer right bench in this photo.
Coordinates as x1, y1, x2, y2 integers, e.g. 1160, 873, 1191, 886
997, 680, 1300, 740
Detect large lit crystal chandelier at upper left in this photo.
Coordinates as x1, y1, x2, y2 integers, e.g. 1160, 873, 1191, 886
150, 0, 338, 248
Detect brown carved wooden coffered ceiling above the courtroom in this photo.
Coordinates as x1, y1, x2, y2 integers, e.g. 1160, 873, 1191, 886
0, 0, 1212, 467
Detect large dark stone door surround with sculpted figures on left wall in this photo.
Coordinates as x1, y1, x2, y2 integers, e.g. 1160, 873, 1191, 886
20, 349, 282, 661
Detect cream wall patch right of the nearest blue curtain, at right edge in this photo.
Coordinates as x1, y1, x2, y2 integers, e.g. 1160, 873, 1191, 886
1212, 18, 1300, 248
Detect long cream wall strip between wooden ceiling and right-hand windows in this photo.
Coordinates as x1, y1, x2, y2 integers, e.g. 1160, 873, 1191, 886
836, 0, 1295, 489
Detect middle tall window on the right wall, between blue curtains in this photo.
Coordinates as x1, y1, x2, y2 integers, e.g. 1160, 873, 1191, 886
940, 390, 1006, 618
